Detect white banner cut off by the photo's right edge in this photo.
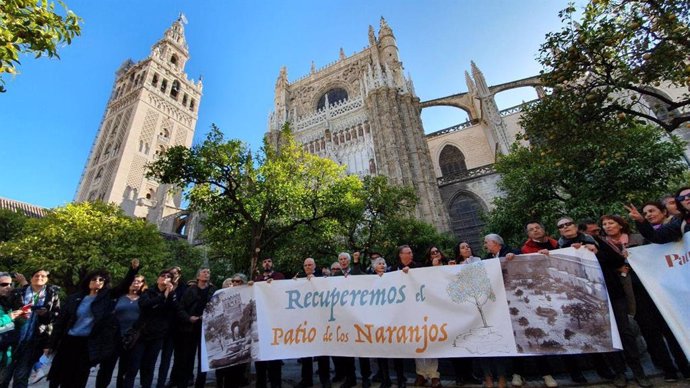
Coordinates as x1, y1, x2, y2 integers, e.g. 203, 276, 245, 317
628, 233, 690, 357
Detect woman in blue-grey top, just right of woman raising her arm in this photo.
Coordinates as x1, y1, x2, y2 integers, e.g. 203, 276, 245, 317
96, 262, 146, 388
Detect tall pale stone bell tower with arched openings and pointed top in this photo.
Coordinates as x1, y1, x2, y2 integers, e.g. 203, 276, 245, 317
75, 15, 203, 239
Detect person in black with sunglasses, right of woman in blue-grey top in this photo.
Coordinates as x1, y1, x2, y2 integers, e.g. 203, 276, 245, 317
124, 269, 177, 388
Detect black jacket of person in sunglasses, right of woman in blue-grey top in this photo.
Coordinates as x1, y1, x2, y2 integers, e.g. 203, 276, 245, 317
135, 285, 177, 341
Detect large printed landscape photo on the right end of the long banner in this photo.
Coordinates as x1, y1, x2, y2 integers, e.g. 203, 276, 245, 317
501, 248, 615, 354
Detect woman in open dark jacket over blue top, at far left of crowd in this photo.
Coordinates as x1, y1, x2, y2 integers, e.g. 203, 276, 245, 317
0, 268, 60, 388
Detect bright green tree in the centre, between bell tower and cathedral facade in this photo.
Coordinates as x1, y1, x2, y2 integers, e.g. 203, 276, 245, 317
147, 125, 361, 272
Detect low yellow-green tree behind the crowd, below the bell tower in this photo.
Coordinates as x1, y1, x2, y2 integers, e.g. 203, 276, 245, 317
0, 202, 167, 293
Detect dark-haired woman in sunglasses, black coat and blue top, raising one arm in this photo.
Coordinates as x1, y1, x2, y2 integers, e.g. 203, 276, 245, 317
48, 259, 139, 387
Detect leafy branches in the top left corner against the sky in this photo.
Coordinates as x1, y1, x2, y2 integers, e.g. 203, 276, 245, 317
0, 0, 82, 92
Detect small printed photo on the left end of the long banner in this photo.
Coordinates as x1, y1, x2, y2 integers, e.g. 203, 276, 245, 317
202, 286, 259, 369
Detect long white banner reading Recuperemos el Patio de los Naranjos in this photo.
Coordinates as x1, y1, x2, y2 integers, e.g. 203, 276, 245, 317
204, 248, 621, 369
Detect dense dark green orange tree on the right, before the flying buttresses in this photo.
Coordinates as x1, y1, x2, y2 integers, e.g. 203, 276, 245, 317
486, 89, 686, 246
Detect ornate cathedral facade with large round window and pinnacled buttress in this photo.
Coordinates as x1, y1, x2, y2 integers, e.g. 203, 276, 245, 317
268, 18, 450, 231
